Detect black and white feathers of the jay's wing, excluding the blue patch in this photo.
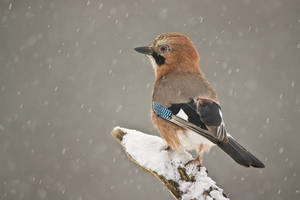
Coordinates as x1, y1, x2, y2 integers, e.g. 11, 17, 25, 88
168, 98, 228, 141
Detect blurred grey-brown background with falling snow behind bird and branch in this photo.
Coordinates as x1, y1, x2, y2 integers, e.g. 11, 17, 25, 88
0, 0, 300, 200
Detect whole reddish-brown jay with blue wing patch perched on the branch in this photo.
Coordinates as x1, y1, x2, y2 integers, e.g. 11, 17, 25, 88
135, 33, 265, 168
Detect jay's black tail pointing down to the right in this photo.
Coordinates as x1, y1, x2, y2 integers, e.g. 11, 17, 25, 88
217, 137, 265, 168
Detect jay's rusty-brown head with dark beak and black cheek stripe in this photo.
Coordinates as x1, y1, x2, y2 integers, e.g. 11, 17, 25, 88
135, 33, 200, 74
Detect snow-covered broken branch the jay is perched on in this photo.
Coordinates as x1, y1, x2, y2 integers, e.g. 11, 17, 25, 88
112, 127, 228, 200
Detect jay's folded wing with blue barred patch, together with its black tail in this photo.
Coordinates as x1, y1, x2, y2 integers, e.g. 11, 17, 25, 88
153, 98, 265, 168
